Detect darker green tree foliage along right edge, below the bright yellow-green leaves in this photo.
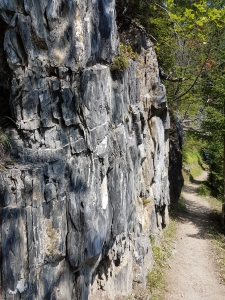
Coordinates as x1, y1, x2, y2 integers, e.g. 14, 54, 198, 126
202, 30, 225, 200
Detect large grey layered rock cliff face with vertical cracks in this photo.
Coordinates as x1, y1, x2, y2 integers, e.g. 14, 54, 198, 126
0, 0, 169, 300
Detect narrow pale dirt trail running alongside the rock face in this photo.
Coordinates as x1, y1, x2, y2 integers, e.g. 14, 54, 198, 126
165, 172, 225, 300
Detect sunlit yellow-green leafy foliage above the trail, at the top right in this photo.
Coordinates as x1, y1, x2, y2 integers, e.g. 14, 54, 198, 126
116, 0, 225, 102
